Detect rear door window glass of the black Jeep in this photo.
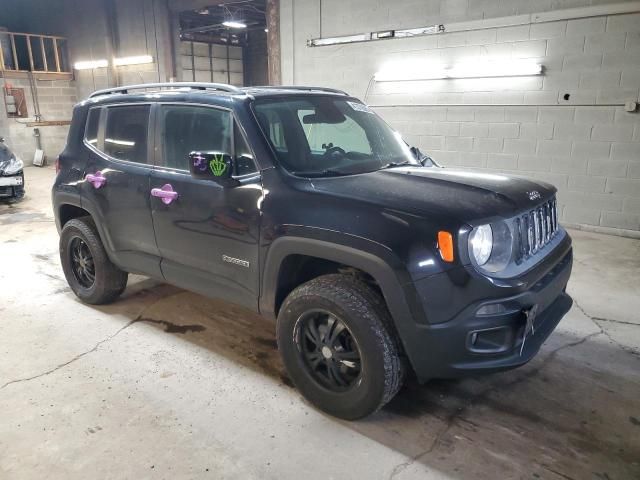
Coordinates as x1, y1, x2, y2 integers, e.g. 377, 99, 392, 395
104, 105, 150, 163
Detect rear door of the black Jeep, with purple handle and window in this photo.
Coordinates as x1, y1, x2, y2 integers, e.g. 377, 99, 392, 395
81, 104, 162, 278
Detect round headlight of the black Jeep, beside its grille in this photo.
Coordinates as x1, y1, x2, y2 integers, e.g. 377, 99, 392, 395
469, 222, 513, 272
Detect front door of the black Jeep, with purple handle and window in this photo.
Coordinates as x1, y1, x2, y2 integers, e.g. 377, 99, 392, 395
151, 104, 262, 309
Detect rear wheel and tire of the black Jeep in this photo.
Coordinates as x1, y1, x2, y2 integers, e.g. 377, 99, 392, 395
60, 217, 128, 305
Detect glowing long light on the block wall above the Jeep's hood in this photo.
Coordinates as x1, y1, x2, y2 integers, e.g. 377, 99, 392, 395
374, 60, 542, 82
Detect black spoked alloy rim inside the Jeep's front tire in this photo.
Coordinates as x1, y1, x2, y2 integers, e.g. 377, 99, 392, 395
296, 310, 362, 392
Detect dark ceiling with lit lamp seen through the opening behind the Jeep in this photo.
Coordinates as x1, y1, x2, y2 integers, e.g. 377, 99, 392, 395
180, 0, 266, 45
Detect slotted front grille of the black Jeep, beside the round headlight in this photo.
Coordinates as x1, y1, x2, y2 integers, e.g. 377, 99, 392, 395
515, 198, 558, 264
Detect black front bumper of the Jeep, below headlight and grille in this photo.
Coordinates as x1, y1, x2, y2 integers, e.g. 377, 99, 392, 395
403, 236, 573, 381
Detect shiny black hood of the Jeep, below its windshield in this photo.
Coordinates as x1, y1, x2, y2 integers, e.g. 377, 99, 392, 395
312, 167, 556, 223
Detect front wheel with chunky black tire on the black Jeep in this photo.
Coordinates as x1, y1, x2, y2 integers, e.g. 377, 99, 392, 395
277, 274, 404, 420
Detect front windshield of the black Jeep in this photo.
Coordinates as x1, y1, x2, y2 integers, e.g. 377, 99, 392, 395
254, 96, 419, 177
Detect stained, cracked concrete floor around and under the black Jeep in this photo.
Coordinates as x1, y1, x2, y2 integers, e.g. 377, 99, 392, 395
0, 167, 640, 480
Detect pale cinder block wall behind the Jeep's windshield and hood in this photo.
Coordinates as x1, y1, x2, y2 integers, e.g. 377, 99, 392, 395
281, 0, 640, 231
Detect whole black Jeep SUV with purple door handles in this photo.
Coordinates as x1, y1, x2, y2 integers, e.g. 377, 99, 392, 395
52, 83, 572, 419
